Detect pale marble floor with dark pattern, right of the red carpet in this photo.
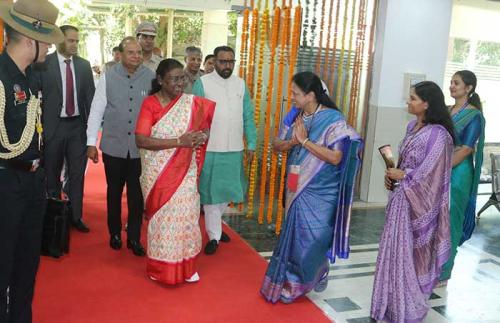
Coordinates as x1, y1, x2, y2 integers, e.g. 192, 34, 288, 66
224, 195, 500, 323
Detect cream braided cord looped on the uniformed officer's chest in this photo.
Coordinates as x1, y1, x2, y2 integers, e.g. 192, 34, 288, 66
0, 81, 42, 159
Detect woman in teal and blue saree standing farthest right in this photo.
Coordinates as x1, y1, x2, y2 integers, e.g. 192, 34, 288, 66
440, 70, 485, 284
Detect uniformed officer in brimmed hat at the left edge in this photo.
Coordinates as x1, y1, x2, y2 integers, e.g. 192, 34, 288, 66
0, 0, 63, 323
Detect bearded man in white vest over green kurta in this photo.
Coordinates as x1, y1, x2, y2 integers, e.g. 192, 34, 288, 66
193, 46, 256, 255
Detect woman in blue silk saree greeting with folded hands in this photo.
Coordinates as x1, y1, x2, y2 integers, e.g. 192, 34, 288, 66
260, 72, 361, 303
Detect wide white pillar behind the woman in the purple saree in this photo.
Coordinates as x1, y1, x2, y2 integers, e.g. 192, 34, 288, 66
360, 0, 453, 202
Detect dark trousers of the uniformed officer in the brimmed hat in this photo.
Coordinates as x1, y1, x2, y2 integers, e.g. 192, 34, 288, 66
0, 169, 46, 323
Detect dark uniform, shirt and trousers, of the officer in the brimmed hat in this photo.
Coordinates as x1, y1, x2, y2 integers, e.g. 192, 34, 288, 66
0, 52, 46, 322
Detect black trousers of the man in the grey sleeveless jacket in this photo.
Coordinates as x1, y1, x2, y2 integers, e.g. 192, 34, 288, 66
102, 153, 144, 241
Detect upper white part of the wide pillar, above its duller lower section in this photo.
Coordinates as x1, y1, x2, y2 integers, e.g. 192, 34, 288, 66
370, 0, 452, 107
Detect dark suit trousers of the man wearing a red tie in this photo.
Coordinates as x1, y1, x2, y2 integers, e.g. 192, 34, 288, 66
44, 116, 87, 221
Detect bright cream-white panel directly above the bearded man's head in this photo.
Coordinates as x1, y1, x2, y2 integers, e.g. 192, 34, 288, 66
201, 10, 229, 55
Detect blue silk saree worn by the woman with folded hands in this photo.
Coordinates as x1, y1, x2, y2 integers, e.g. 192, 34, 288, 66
260, 109, 361, 303
